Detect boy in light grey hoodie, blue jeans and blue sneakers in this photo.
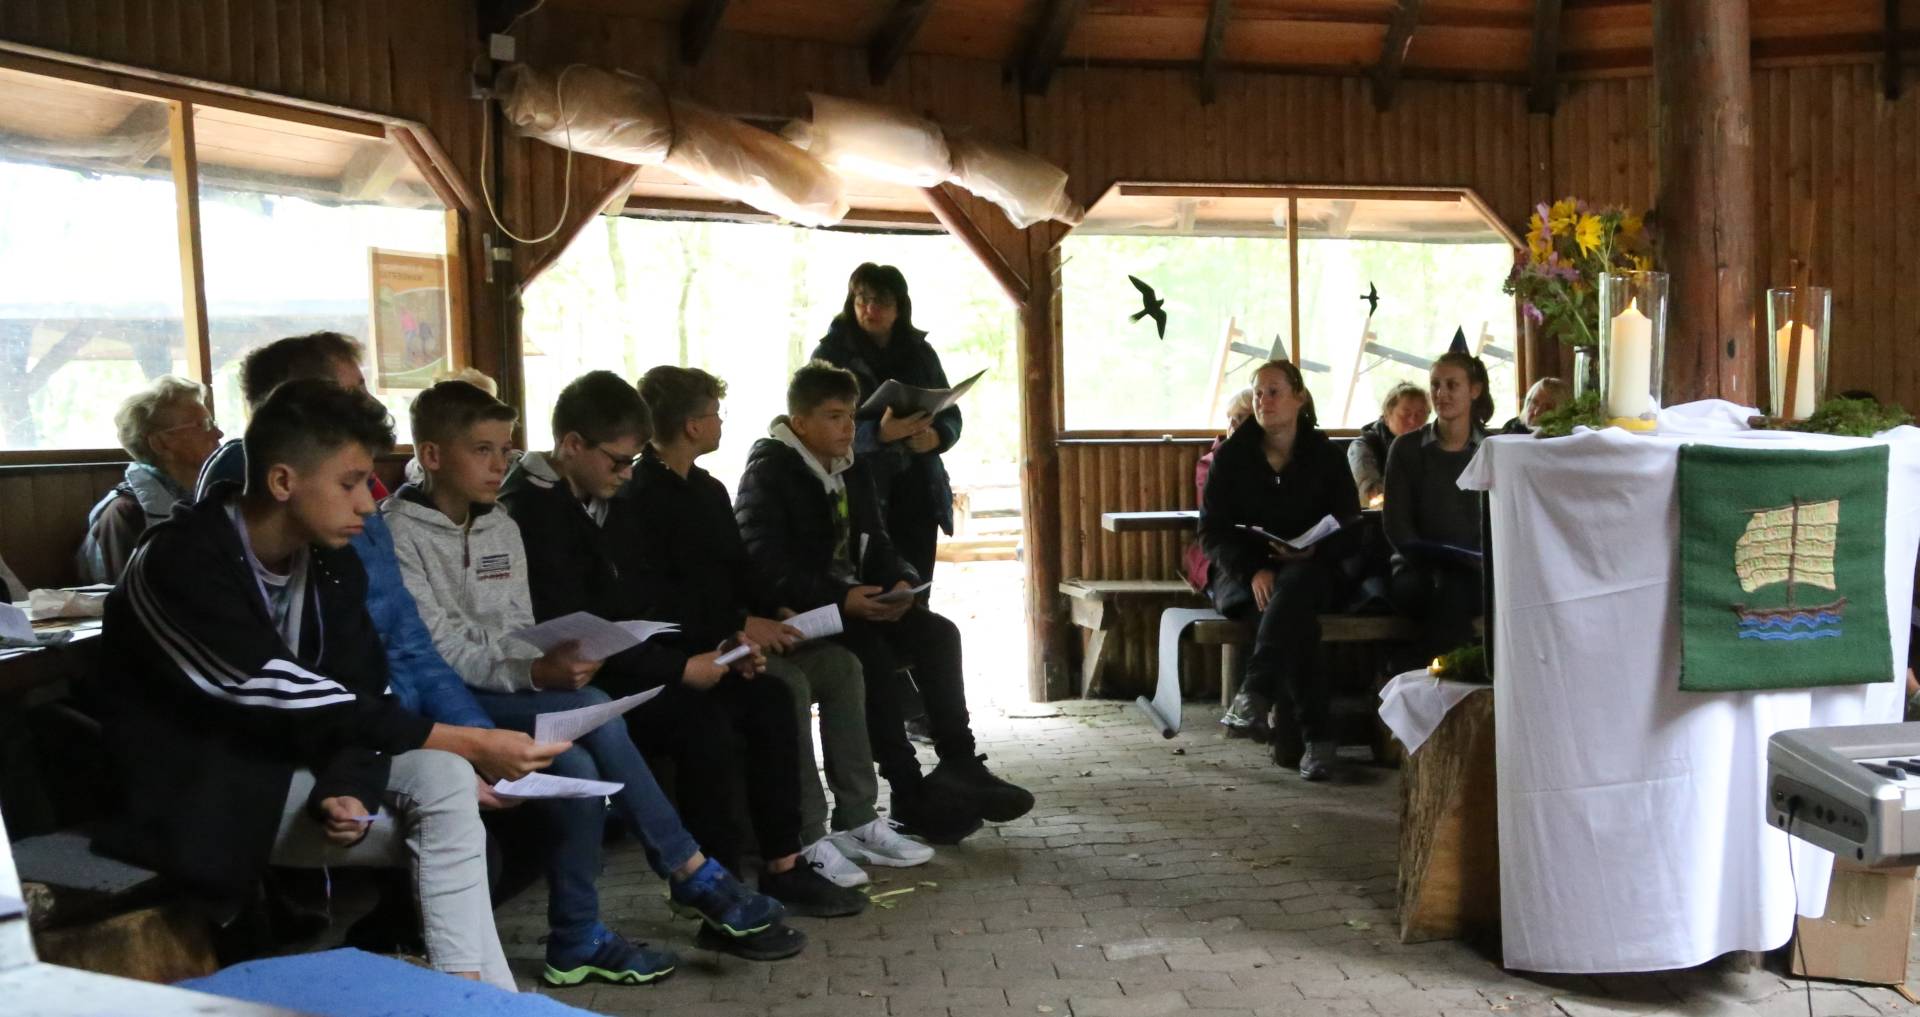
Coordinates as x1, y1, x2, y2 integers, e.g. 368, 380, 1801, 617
382, 382, 806, 984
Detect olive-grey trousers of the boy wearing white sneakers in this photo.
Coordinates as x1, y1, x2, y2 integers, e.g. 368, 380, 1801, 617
766, 639, 879, 844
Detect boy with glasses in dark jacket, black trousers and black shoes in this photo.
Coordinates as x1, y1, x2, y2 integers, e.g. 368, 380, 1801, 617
499, 370, 866, 913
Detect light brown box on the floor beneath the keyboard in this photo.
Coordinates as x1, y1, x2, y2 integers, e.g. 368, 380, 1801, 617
1788, 858, 1914, 984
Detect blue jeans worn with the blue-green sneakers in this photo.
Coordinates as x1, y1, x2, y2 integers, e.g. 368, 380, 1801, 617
474, 687, 701, 946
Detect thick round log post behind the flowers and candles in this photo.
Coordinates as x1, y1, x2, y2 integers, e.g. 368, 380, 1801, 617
1653, 0, 1757, 405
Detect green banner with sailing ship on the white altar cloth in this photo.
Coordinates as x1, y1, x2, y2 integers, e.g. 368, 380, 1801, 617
1680, 445, 1893, 693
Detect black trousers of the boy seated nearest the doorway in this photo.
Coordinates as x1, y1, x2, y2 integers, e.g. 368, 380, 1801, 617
833, 606, 973, 791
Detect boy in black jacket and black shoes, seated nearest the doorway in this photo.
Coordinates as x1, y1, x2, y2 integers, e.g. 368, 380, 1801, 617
733, 361, 1033, 844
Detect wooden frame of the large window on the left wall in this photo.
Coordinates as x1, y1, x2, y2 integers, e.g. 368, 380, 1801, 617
0, 40, 480, 468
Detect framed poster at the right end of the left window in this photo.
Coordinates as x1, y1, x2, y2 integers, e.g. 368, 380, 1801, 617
367, 248, 447, 391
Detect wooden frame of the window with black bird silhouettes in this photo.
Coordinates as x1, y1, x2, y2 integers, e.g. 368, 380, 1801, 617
1048, 180, 1528, 445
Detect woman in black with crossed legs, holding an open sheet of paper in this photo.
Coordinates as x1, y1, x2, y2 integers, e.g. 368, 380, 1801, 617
1200, 361, 1359, 781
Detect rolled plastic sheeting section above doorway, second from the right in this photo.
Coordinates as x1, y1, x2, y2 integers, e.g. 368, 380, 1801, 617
787, 92, 952, 188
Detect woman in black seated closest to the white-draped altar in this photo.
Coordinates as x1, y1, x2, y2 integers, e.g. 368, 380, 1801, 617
1386, 353, 1494, 660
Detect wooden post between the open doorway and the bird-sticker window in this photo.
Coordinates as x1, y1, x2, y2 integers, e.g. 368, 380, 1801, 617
1018, 226, 1073, 702
